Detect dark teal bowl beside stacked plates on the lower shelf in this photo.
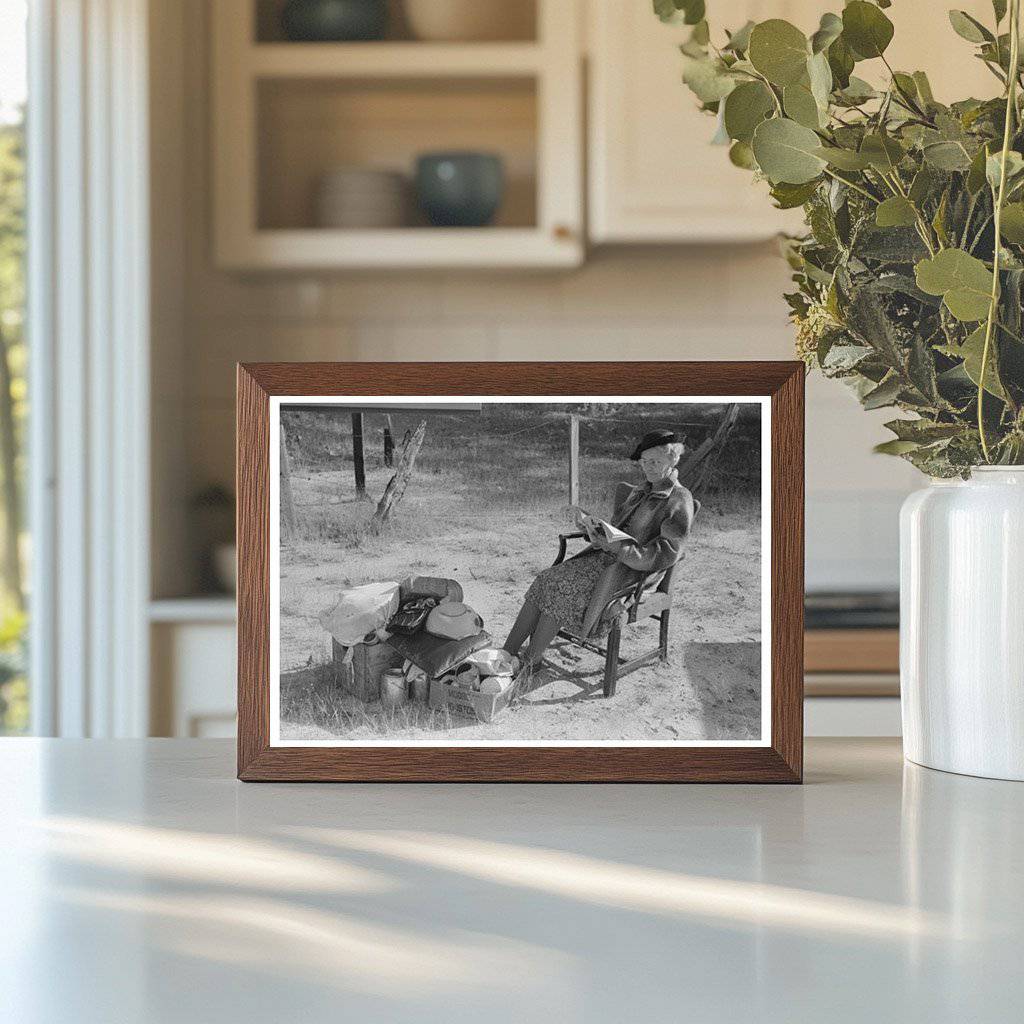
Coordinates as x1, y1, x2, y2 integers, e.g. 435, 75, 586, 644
416, 153, 505, 227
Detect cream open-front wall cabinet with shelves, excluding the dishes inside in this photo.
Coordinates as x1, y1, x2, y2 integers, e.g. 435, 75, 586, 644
212, 0, 584, 269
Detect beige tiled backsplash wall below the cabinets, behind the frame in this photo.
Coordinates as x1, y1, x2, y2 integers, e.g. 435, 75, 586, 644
178, 245, 915, 589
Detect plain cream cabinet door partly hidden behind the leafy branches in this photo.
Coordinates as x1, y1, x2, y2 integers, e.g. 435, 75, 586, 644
589, 0, 820, 242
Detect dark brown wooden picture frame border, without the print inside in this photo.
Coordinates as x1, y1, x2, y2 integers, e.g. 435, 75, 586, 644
237, 361, 804, 782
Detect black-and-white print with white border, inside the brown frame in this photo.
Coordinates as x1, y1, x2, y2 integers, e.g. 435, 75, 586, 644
270, 395, 771, 746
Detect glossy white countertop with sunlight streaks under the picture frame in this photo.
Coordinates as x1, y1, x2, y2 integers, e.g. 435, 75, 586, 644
0, 739, 1024, 1024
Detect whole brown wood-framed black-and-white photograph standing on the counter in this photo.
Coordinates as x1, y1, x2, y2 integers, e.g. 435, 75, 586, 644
238, 361, 804, 782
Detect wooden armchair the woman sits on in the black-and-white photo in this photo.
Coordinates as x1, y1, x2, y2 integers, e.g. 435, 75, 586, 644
552, 534, 679, 697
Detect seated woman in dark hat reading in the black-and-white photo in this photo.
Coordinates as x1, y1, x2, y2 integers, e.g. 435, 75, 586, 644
505, 430, 693, 673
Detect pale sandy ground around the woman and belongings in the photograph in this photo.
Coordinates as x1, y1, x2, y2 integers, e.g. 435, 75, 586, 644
281, 460, 761, 742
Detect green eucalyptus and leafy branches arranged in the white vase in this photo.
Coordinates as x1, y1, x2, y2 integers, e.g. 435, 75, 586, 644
654, 0, 1024, 477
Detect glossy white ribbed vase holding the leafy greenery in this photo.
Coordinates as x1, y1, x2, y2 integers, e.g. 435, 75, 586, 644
900, 466, 1024, 781
